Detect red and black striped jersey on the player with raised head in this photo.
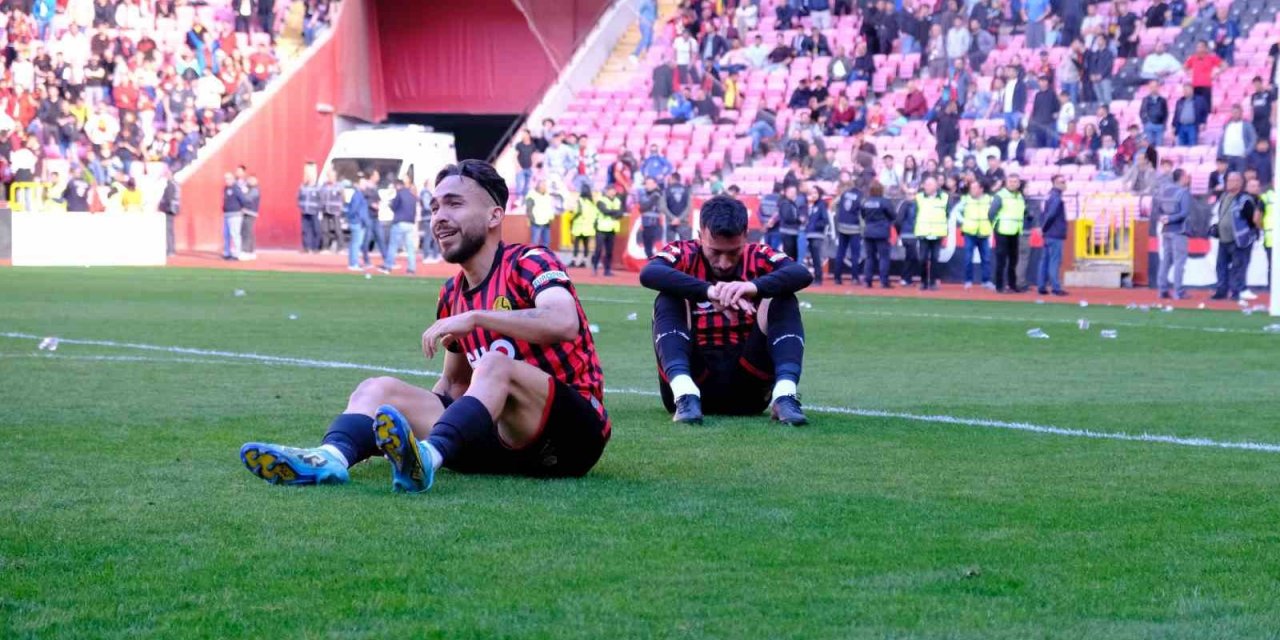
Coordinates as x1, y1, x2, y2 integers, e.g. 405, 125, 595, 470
435, 244, 604, 417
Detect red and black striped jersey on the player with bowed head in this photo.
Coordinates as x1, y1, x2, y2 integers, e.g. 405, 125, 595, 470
653, 241, 795, 347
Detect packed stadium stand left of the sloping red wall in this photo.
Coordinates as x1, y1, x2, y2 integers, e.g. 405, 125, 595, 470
0, 0, 330, 210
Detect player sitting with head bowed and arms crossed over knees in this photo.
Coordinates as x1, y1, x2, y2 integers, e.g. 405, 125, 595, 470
640, 196, 813, 426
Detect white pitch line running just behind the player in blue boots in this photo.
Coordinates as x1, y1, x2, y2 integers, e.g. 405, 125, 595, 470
0, 332, 1280, 453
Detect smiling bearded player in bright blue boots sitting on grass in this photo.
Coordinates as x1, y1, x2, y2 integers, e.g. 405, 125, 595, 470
241, 160, 611, 492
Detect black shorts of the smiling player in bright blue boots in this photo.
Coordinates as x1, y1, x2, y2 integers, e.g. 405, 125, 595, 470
438, 378, 611, 477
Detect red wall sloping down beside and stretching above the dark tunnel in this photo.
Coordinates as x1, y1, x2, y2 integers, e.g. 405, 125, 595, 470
177, 0, 611, 251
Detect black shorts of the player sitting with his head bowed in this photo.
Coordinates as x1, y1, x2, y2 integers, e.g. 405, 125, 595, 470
658, 328, 773, 416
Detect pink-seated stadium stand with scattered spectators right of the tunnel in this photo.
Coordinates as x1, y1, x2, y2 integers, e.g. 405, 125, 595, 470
509, 0, 1280, 207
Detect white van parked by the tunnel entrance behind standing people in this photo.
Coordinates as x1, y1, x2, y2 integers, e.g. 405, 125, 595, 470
321, 124, 458, 221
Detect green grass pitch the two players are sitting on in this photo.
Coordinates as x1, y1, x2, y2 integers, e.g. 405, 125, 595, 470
0, 269, 1280, 639
